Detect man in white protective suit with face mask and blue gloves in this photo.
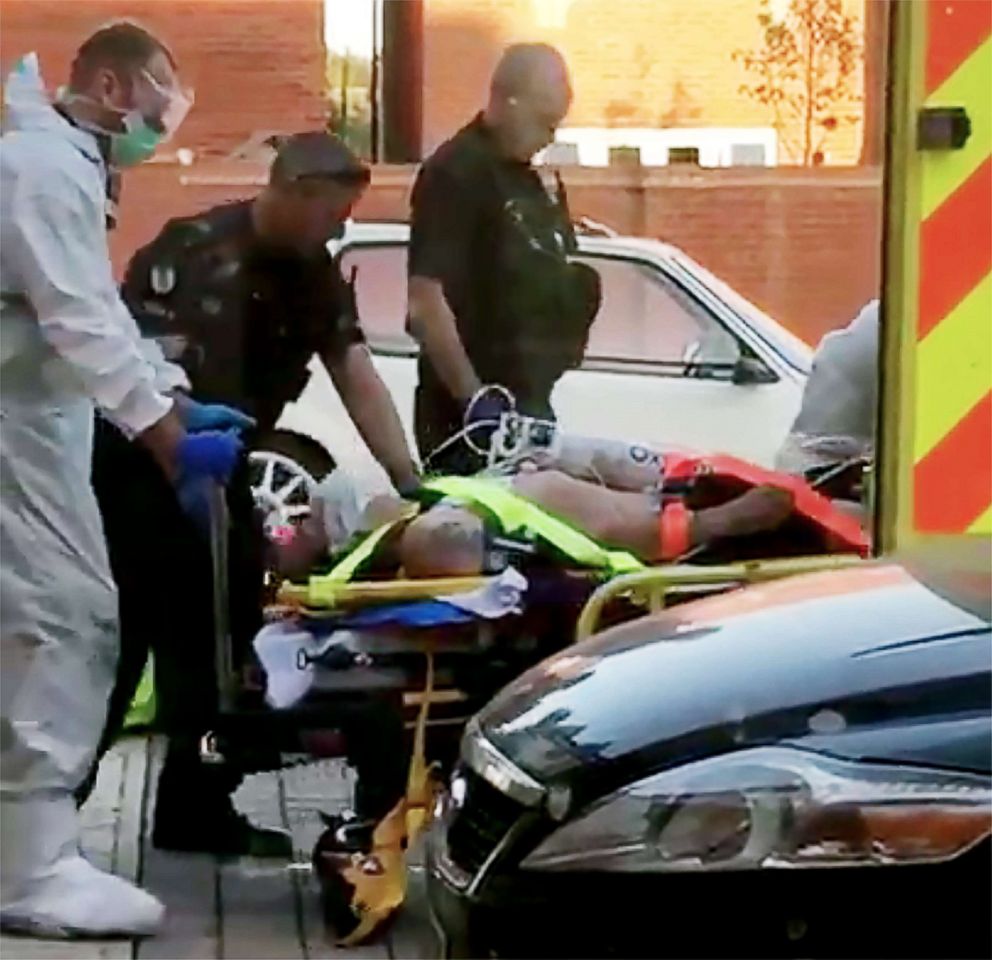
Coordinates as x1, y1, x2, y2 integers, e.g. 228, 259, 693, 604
0, 23, 241, 936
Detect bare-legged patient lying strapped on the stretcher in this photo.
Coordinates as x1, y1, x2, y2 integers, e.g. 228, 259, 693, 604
274, 438, 868, 578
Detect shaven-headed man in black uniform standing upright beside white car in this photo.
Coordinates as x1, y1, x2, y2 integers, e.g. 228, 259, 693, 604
408, 44, 600, 473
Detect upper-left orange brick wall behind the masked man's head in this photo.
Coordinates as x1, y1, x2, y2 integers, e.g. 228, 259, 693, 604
0, 0, 325, 154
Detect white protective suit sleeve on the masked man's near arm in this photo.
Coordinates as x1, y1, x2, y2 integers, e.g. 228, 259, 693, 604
4, 167, 172, 434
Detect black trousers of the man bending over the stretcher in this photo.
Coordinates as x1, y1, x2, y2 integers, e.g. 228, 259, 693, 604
76, 417, 263, 792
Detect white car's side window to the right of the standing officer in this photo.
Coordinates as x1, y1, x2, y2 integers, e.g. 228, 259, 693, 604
580, 256, 740, 373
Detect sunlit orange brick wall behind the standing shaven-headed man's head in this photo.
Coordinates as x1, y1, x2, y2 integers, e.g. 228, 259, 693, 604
423, 0, 868, 164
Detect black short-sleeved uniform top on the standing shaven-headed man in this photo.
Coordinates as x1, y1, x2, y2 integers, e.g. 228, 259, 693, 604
408, 115, 576, 419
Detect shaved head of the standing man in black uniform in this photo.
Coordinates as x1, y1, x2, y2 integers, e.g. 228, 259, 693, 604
485, 43, 572, 162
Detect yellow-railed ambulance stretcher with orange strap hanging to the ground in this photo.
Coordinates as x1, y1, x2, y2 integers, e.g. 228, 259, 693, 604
205, 418, 861, 945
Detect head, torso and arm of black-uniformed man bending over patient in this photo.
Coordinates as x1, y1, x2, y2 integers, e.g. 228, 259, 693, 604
123, 131, 417, 492
